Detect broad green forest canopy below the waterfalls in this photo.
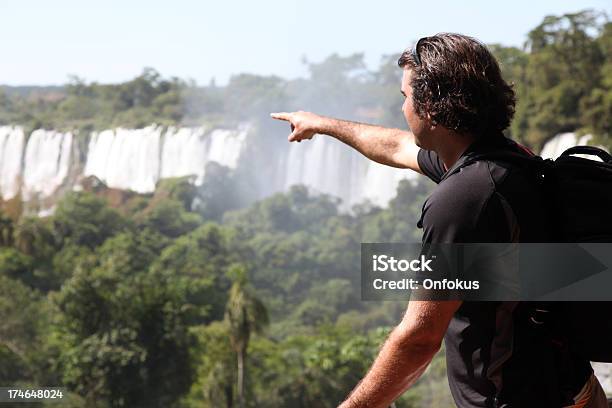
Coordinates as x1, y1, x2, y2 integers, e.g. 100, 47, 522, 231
0, 175, 443, 407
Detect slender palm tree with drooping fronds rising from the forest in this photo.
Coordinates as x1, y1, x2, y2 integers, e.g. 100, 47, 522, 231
225, 264, 268, 408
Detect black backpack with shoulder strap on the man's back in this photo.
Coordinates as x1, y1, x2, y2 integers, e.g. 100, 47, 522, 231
444, 146, 612, 363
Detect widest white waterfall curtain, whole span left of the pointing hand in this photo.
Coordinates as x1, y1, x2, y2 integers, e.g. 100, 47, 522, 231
84, 125, 248, 193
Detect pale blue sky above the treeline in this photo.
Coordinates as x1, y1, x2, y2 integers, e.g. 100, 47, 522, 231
0, 0, 612, 85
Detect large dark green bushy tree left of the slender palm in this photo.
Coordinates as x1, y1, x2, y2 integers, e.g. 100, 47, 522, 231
54, 233, 193, 407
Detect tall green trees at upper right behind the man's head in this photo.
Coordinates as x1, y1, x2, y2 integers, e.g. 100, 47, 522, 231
504, 10, 612, 148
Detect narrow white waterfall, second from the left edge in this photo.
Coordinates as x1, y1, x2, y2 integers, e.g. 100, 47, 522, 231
23, 129, 73, 201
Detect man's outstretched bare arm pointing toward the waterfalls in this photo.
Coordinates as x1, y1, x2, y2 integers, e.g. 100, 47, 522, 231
271, 111, 421, 172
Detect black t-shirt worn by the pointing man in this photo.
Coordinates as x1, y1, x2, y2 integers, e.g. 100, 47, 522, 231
418, 136, 592, 408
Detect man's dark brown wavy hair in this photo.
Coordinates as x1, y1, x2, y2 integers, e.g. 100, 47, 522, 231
397, 33, 516, 137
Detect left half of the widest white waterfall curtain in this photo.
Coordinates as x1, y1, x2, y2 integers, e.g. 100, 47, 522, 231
84, 126, 162, 193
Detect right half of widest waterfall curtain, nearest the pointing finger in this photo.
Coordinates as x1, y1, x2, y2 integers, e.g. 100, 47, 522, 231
160, 127, 247, 184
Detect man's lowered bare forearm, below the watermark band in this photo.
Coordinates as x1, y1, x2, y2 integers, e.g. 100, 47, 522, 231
340, 301, 461, 408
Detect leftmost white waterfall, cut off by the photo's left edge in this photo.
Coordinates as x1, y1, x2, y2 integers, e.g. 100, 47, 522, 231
0, 126, 25, 200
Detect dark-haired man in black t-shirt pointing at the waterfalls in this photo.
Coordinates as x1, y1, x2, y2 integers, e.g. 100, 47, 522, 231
272, 34, 607, 408
